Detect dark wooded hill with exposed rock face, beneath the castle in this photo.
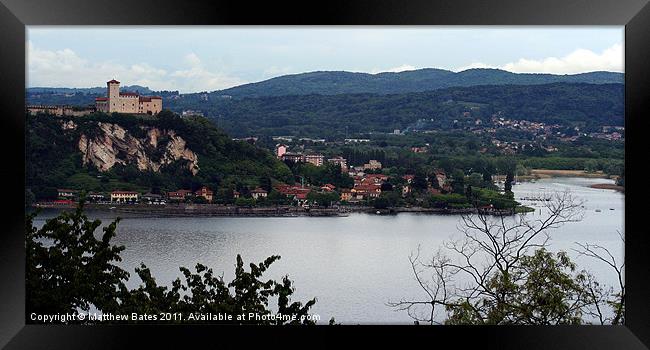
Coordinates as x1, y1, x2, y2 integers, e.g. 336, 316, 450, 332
25, 111, 293, 199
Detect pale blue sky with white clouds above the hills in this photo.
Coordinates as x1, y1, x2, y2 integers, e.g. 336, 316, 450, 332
26, 26, 624, 93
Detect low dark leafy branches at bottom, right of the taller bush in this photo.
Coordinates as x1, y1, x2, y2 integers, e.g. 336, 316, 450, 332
116, 255, 316, 325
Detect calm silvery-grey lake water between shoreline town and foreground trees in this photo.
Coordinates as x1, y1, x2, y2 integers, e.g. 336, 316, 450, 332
35, 178, 624, 324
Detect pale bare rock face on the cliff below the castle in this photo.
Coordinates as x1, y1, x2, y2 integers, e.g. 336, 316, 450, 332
79, 123, 199, 175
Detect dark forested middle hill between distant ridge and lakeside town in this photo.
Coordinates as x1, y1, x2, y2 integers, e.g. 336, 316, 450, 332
166, 83, 624, 137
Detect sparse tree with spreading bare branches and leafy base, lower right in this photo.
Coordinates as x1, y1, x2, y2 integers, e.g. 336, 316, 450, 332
388, 192, 624, 325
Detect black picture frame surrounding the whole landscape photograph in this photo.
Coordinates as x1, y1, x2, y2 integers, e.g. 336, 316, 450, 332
0, 0, 650, 349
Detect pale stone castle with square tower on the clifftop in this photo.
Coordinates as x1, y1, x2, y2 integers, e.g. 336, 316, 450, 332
95, 79, 162, 114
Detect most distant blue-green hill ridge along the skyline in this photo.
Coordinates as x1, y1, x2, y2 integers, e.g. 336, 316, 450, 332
211, 68, 624, 98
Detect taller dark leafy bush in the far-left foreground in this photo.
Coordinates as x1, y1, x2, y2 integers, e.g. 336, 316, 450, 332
25, 200, 129, 319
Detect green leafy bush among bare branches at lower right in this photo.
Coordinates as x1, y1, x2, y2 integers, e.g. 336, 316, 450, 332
445, 249, 588, 325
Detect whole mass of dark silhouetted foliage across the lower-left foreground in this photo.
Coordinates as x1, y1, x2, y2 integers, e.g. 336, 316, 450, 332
25, 200, 316, 324
